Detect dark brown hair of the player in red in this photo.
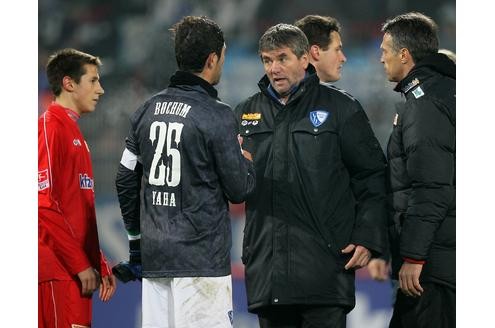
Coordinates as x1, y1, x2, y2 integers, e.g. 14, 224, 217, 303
46, 48, 101, 97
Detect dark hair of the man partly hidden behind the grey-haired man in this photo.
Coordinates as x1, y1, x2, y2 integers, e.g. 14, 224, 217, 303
294, 15, 341, 50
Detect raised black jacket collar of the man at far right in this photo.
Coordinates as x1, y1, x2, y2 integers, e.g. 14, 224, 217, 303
394, 53, 455, 94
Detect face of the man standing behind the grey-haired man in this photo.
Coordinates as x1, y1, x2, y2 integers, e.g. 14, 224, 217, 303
315, 31, 347, 82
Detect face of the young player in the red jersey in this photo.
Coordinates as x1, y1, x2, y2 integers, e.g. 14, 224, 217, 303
72, 64, 105, 114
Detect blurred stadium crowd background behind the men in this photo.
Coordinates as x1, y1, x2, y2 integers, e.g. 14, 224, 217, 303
38, 0, 456, 198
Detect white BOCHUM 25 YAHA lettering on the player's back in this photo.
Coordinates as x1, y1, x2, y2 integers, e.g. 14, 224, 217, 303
149, 101, 191, 207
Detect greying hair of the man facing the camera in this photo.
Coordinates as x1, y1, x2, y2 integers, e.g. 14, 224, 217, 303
258, 24, 309, 58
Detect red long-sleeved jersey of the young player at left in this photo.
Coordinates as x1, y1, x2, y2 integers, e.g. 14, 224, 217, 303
38, 103, 110, 282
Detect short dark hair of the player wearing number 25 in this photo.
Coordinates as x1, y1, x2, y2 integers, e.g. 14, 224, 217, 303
170, 16, 225, 73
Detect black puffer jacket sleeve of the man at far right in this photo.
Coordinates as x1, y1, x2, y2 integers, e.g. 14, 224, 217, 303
399, 98, 455, 260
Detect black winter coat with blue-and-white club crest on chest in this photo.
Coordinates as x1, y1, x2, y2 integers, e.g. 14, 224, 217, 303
236, 65, 387, 312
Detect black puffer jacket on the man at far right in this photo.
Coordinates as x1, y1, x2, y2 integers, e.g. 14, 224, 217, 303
387, 54, 456, 288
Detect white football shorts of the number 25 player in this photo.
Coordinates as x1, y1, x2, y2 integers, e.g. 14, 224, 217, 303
142, 275, 233, 328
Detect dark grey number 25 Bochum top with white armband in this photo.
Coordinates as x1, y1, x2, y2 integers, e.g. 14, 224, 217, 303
116, 71, 255, 278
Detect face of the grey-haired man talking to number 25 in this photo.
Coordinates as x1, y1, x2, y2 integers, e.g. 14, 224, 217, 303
261, 47, 309, 97
